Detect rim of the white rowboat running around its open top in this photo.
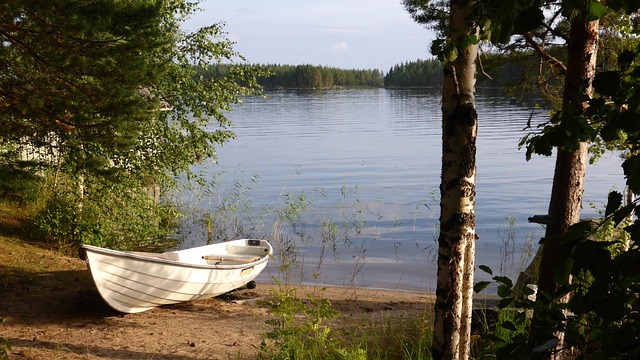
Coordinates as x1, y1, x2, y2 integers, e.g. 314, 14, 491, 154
81, 239, 273, 270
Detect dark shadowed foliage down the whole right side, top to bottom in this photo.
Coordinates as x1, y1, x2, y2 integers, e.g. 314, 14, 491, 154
405, 0, 640, 358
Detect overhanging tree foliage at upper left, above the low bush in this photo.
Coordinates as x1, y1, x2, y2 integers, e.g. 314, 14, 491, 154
0, 0, 259, 179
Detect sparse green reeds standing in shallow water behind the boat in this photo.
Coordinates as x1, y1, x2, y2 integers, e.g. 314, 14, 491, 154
169, 167, 392, 284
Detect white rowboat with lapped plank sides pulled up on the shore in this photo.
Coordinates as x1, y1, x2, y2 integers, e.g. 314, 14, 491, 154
80, 239, 273, 313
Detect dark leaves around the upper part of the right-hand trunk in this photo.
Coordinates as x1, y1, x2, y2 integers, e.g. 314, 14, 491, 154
469, 0, 639, 159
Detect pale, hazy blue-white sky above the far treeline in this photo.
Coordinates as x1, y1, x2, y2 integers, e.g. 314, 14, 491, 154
183, 0, 434, 73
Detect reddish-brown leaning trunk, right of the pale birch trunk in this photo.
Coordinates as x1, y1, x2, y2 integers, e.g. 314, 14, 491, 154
531, 9, 599, 358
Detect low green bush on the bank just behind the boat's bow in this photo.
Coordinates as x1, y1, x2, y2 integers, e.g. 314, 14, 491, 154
32, 172, 177, 252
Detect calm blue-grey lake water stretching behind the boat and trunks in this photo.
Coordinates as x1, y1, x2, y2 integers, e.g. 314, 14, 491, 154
176, 89, 623, 291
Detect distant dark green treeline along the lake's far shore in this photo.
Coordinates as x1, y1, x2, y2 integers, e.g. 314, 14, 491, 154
202, 59, 523, 89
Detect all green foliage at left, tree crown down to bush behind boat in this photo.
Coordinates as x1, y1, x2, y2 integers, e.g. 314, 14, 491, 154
0, 0, 261, 248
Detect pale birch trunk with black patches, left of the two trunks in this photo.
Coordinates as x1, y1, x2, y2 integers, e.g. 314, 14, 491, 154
431, 1, 478, 360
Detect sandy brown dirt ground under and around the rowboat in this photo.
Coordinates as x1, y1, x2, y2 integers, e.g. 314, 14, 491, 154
0, 237, 444, 360
